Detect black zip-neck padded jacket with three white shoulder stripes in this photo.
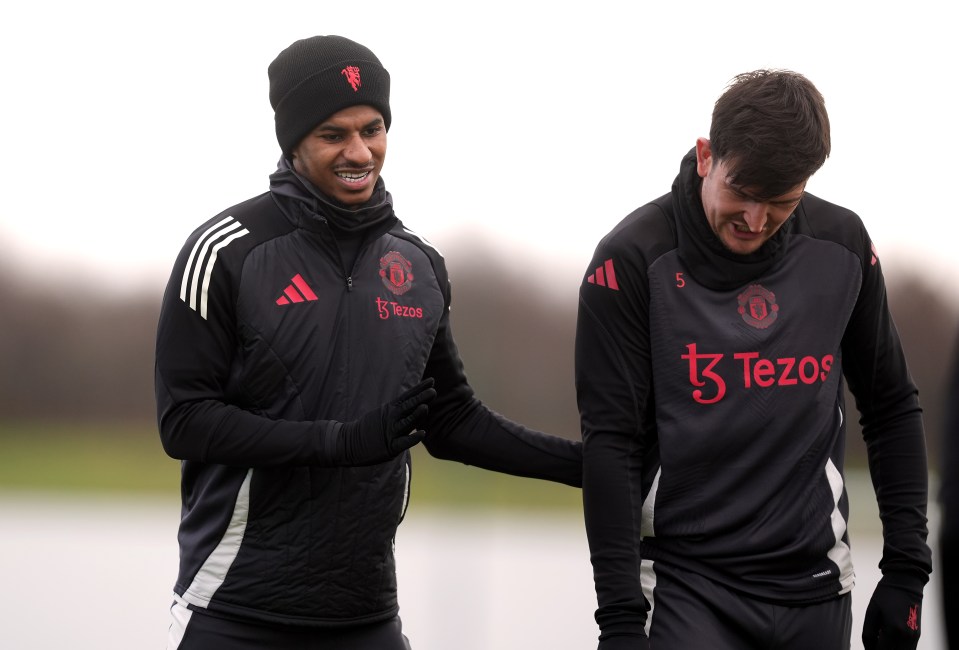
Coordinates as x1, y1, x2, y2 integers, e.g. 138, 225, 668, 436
156, 165, 582, 626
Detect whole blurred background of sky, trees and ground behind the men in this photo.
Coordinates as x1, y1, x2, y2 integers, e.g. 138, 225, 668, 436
0, 0, 959, 650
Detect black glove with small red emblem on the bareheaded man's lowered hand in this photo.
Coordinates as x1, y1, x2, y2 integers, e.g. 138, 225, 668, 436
862, 577, 922, 650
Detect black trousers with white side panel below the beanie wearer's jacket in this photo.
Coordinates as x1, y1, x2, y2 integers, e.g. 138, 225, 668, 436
167, 604, 410, 650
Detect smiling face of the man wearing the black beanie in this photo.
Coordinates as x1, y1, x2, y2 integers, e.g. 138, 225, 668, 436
292, 106, 386, 207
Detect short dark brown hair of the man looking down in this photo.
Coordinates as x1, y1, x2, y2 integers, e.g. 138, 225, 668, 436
709, 70, 830, 199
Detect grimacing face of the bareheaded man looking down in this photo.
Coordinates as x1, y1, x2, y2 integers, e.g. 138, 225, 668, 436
696, 138, 806, 255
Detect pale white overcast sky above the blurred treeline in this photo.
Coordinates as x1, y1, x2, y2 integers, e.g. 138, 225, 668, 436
0, 0, 959, 290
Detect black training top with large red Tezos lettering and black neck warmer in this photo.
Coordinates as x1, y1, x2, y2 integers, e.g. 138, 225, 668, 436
576, 152, 931, 638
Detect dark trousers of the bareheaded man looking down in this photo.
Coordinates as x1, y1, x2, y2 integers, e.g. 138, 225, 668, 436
643, 562, 852, 650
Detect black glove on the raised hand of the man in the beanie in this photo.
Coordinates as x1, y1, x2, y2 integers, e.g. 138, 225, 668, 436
337, 378, 436, 465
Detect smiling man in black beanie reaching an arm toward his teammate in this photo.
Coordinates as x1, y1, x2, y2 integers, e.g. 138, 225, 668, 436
156, 36, 582, 650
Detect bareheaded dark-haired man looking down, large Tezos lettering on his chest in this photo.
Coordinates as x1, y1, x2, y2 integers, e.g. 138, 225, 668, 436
576, 70, 931, 650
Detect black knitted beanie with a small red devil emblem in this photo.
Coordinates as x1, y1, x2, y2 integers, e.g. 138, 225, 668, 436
268, 36, 390, 155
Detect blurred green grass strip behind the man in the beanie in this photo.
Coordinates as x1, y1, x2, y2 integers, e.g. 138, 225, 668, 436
0, 423, 582, 513
